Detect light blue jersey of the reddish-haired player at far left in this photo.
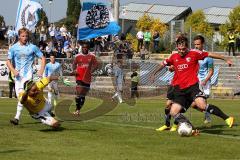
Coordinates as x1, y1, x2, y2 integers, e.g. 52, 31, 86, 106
8, 42, 43, 80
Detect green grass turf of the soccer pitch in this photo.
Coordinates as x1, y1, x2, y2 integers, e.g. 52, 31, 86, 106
0, 98, 240, 160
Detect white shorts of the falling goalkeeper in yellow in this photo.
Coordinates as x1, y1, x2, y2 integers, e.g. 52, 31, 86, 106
31, 100, 56, 126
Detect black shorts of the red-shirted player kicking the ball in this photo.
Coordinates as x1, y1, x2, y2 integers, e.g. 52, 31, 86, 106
172, 83, 206, 112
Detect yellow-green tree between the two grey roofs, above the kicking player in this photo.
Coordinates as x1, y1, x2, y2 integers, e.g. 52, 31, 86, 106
185, 10, 213, 38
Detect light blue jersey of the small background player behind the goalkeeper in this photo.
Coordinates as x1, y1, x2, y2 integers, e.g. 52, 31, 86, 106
45, 62, 62, 77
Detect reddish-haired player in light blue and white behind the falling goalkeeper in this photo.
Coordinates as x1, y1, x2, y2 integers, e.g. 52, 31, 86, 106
6, 28, 46, 125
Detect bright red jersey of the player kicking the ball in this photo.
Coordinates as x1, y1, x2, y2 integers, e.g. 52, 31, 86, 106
162, 50, 208, 89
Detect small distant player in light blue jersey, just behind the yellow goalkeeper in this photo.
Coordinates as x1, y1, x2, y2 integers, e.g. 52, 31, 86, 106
45, 53, 62, 106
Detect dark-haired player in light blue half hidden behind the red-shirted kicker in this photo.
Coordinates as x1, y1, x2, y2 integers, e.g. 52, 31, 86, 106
194, 35, 214, 124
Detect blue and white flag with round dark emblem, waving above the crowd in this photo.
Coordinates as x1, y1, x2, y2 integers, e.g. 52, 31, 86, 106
77, 0, 120, 40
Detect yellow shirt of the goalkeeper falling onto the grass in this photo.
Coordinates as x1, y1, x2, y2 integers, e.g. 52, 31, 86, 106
19, 77, 49, 114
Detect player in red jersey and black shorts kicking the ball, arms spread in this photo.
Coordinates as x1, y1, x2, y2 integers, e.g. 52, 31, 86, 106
150, 36, 234, 134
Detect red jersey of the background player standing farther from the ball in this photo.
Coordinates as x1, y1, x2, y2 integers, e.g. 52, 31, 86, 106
73, 53, 98, 84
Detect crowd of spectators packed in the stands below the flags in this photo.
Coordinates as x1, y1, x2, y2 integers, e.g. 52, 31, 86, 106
0, 21, 133, 59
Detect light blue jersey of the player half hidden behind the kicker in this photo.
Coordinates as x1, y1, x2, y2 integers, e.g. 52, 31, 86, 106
198, 57, 213, 81
